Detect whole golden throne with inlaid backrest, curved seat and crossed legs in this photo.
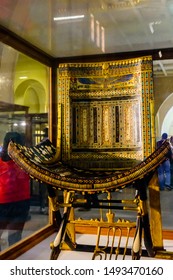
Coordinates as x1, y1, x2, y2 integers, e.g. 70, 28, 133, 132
9, 57, 173, 259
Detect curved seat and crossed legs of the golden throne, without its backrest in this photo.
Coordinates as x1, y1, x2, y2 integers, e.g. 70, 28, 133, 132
8, 139, 173, 260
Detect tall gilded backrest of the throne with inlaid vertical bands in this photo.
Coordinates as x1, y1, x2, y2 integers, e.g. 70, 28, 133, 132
58, 57, 154, 169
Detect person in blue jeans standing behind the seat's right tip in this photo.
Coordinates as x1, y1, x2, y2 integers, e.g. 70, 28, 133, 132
157, 133, 171, 191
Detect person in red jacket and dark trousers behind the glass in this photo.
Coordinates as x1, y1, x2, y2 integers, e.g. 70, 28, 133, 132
0, 132, 30, 249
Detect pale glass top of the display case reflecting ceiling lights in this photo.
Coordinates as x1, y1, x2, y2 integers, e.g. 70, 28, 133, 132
0, 0, 173, 75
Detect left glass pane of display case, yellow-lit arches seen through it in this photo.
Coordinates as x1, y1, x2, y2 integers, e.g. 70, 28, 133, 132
0, 43, 49, 251
